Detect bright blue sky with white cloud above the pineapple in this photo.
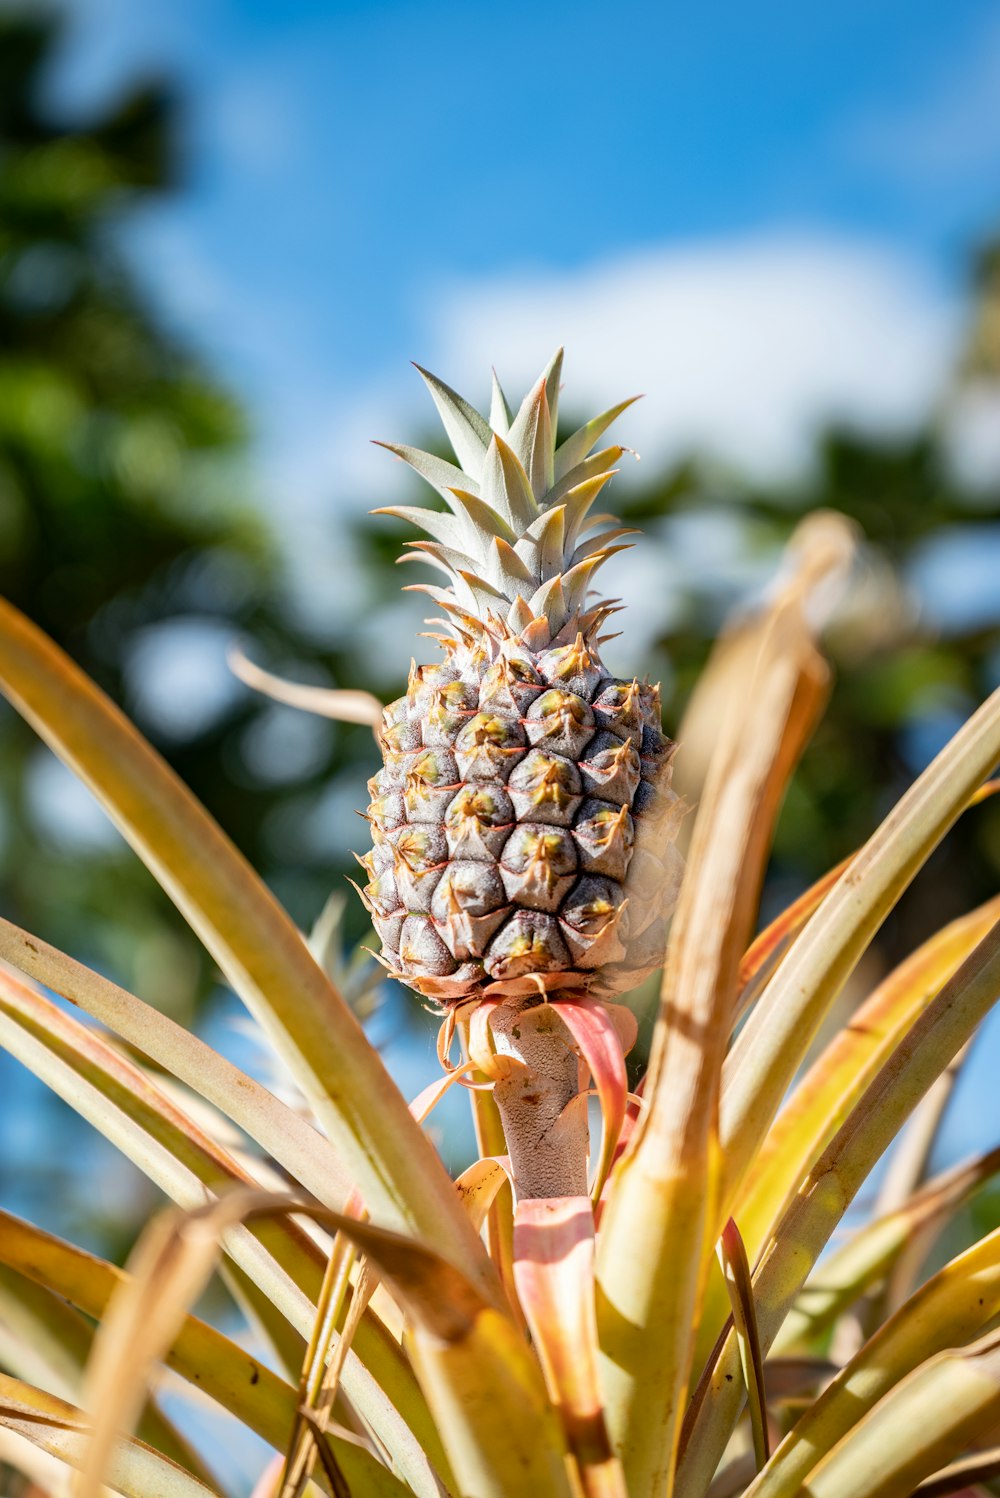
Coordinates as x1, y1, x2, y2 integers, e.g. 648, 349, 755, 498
52, 0, 1000, 521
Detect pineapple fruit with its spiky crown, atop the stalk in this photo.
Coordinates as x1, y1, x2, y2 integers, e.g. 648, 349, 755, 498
361, 351, 678, 1007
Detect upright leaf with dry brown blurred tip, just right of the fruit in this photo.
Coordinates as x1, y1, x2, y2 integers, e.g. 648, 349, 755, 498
597, 526, 844, 1494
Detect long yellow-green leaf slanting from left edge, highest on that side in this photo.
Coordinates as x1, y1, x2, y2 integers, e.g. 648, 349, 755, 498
0, 602, 499, 1296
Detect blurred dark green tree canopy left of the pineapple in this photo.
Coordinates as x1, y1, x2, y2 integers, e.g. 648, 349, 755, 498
0, 7, 371, 1007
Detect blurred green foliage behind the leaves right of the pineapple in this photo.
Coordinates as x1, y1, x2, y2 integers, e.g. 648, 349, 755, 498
620, 416, 1000, 962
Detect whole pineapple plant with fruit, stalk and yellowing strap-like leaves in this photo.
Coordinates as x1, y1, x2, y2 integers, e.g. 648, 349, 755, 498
0, 344, 1000, 1498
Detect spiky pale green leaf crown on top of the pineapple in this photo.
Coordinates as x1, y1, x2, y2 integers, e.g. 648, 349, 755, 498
373, 349, 638, 652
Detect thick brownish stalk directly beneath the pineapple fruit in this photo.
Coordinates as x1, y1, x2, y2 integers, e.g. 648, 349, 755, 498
491, 999, 588, 1200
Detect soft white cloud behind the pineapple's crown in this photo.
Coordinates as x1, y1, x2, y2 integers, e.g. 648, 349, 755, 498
306, 234, 960, 502
